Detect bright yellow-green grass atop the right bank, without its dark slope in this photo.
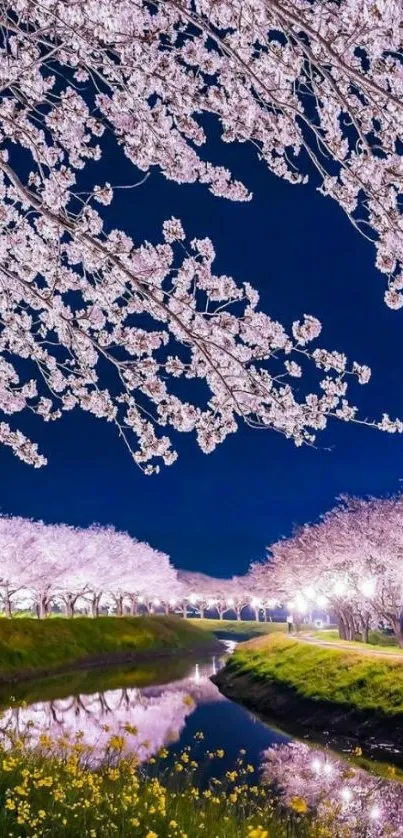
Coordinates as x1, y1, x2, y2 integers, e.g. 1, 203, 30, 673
228, 635, 403, 716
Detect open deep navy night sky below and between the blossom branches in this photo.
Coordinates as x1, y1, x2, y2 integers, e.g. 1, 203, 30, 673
0, 130, 403, 576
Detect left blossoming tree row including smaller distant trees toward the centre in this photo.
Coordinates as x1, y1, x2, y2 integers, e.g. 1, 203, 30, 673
0, 516, 272, 619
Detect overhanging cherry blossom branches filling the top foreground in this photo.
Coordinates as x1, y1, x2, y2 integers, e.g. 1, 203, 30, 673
0, 0, 403, 473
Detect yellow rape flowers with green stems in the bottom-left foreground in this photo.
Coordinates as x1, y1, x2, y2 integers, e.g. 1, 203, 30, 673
0, 728, 348, 838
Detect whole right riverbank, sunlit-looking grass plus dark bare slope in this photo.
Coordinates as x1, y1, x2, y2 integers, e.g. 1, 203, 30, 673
212, 635, 403, 758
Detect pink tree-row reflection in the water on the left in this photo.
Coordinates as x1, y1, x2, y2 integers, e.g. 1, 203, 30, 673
0, 658, 225, 762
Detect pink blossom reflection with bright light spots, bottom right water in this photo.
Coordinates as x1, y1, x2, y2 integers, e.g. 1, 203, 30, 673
262, 742, 403, 838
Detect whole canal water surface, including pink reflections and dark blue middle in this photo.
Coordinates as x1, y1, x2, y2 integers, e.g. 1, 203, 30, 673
0, 646, 403, 838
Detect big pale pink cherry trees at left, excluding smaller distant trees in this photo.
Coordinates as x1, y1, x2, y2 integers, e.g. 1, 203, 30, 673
0, 516, 180, 617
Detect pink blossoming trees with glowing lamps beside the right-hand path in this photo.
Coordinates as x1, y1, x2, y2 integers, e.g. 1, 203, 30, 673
251, 496, 403, 646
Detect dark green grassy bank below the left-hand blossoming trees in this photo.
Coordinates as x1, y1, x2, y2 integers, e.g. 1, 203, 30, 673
0, 616, 214, 679
